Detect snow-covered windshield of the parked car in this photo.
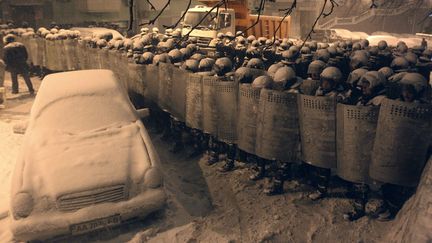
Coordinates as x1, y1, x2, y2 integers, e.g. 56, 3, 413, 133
34, 96, 136, 133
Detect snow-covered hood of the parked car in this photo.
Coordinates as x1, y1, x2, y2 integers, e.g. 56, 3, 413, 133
23, 123, 151, 198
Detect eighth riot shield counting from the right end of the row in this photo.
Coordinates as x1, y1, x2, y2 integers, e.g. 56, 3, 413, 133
186, 74, 204, 130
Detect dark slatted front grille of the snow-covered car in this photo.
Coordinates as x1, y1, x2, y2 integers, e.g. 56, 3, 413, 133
57, 185, 127, 212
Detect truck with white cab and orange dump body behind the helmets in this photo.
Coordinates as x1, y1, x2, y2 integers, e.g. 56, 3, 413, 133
182, 0, 291, 47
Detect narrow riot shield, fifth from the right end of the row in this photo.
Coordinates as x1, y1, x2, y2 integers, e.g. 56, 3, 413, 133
237, 84, 261, 154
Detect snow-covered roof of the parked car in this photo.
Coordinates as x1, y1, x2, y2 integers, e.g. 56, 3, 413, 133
31, 69, 129, 116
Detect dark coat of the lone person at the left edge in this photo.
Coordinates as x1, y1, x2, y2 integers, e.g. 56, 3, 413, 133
3, 42, 28, 73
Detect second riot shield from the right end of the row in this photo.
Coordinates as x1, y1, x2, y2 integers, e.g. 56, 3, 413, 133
336, 104, 379, 183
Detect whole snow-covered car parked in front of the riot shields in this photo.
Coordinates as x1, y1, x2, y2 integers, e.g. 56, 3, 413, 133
10, 70, 166, 241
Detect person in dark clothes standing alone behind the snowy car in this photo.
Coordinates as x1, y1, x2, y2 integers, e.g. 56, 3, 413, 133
3, 34, 34, 94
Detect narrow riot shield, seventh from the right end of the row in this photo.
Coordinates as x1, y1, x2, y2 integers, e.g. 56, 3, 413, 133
202, 76, 219, 137
